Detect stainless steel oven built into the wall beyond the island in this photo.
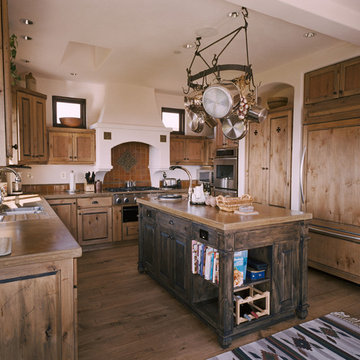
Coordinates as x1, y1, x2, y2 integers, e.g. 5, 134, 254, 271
214, 148, 238, 196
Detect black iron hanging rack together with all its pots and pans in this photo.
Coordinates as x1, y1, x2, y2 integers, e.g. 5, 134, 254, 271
183, 7, 267, 140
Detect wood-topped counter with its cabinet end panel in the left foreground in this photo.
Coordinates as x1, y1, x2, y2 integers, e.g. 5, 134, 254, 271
0, 195, 81, 360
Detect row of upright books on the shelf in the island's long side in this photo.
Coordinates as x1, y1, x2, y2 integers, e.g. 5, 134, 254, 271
192, 240, 219, 284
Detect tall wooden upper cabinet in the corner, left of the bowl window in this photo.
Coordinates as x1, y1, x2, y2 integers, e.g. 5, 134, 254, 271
12, 87, 47, 164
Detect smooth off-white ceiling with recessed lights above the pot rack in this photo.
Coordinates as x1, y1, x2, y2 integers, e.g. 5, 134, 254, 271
8, 0, 360, 94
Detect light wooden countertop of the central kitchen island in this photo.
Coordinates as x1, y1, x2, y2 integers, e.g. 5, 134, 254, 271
137, 196, 312, 230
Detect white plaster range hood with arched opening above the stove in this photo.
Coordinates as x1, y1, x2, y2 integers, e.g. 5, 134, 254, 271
90, 84, 171, 184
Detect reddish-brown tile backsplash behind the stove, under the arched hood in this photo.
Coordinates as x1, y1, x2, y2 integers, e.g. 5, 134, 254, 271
103, 142, 151, 188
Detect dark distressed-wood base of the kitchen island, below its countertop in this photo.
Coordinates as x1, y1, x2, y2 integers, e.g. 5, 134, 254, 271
139, 199, 309, 348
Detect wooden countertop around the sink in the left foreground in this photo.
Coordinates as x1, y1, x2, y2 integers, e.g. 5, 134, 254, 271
0, 195, 82, 268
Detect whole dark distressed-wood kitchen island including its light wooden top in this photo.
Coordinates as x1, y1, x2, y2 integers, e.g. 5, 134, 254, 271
138, 197, 312, 347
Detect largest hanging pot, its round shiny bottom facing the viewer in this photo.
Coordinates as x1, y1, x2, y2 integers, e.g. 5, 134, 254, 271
202, 82, 240, 119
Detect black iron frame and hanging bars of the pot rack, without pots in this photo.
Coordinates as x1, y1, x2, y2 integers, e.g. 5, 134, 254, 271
183, 7, 256, 94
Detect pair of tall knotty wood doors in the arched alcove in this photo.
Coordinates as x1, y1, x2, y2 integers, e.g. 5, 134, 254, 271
246, 109, 292, 208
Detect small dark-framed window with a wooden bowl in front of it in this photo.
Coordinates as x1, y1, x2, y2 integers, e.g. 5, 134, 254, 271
52, 96, 86, 129
